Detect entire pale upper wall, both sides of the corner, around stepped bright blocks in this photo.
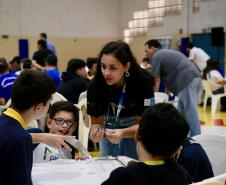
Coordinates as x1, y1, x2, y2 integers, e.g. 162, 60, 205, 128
0, 0, 226, 37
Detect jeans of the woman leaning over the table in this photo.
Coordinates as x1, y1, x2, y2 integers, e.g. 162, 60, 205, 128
100, 138, 138, 159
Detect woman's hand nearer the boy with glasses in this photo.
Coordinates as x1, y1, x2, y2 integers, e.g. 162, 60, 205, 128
89, 124, 104, 142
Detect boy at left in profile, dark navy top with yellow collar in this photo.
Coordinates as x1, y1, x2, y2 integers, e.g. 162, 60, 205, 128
0, 70, 55, 185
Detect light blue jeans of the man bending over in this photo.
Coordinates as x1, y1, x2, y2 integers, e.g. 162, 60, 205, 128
177, 78, 201, 137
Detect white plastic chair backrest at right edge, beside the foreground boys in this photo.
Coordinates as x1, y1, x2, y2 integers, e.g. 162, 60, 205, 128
193, 134, 226, 175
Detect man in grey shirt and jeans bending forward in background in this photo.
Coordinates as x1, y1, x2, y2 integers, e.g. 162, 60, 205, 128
145, 39, 202, 137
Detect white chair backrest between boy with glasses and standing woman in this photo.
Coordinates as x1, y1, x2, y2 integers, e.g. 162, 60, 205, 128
78, 97, 91, 149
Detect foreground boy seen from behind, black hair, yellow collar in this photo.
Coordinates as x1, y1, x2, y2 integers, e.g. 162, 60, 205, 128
102, 103, 191, 185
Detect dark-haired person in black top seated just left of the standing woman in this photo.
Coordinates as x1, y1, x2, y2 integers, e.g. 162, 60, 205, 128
57, 58, 88, 104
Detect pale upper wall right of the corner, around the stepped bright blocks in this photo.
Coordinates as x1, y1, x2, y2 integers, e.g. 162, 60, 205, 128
120, 0, 226, 37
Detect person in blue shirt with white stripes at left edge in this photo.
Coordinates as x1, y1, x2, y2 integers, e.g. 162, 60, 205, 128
0, 58, 17, 105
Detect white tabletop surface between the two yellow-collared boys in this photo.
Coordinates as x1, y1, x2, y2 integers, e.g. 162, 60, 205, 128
32, 157, 134, 185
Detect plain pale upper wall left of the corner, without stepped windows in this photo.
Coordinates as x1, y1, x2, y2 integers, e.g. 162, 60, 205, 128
0, 0, 120, 37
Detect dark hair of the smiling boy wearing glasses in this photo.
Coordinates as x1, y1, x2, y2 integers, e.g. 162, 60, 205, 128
49, 101, 79, 123
